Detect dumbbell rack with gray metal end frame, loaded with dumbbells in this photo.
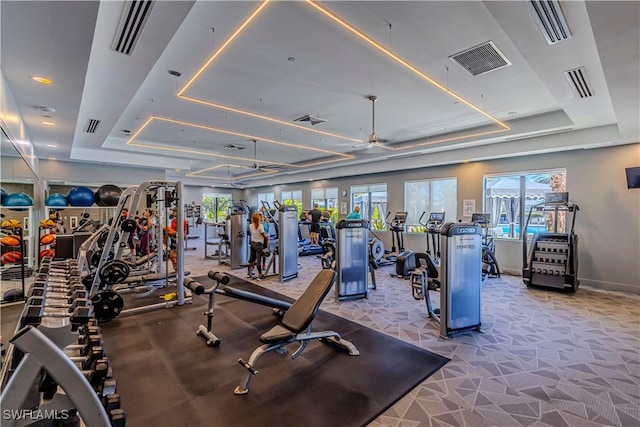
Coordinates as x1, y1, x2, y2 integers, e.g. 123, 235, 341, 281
0, 258, 126, 427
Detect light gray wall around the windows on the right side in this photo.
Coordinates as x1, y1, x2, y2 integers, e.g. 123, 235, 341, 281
244, 144, 640, 293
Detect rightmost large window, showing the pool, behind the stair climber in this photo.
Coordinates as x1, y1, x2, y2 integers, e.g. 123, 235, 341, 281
484, 169, 567, 239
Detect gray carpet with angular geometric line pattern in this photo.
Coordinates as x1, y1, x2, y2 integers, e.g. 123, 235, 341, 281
185, 241, 640, 427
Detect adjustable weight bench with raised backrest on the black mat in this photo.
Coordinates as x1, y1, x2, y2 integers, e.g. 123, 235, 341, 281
233, 270, 360, 395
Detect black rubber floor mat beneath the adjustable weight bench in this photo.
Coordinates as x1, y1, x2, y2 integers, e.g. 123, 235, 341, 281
102, 277, 449, 427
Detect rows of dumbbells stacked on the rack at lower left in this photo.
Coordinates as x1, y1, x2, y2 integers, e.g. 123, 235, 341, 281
20, 258, 126, 427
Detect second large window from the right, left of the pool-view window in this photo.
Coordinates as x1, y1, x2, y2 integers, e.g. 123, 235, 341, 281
404, 178, 458, 233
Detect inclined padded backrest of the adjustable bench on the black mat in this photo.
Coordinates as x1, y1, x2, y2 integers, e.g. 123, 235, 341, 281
282, 270, 337, 333
